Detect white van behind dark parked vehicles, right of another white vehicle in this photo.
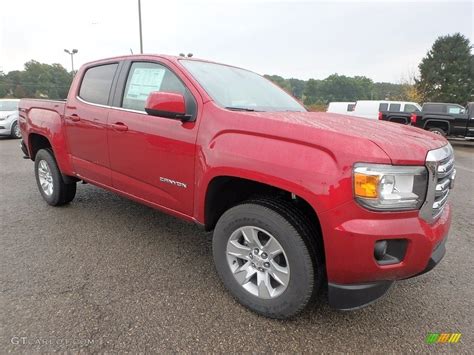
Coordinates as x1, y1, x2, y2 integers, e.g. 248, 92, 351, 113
352, 100, 421, 120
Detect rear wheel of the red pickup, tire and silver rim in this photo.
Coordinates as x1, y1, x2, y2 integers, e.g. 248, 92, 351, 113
35, 149, 76, 206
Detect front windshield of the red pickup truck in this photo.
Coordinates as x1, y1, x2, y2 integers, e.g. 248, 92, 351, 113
181, 60, 306, 112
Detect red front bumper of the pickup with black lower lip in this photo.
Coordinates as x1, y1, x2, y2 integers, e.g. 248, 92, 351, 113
321, 202, 451, 309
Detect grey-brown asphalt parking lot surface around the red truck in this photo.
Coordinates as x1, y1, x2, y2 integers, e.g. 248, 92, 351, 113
0, 139, 474, 353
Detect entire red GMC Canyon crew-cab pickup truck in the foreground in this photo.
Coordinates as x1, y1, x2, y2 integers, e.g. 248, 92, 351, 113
19, 55, 455, 318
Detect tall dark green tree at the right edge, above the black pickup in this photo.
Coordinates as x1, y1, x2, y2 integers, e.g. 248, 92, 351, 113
416, 33, 474, 104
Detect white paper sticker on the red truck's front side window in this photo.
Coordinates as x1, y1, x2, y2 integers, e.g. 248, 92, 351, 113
125, 68, 166, 101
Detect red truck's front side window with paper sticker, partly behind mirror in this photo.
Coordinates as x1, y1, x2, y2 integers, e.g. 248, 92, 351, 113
122, 62, 188, 112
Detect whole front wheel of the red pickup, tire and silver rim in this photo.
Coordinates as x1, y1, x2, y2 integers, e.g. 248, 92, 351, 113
213, 199, 323, 319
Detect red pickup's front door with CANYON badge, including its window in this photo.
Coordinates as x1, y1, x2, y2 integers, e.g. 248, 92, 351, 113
108, 61, 198, 215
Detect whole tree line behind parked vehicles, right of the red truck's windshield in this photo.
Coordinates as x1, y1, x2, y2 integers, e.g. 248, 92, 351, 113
265, 33, 474, 107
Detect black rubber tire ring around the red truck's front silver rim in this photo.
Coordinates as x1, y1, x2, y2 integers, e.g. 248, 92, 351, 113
213, 204, 314, 318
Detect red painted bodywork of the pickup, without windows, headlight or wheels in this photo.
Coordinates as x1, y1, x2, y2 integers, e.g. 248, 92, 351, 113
20, 55, 451, 283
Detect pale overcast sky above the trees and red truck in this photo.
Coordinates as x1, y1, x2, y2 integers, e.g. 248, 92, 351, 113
0, 0, 474, 83
